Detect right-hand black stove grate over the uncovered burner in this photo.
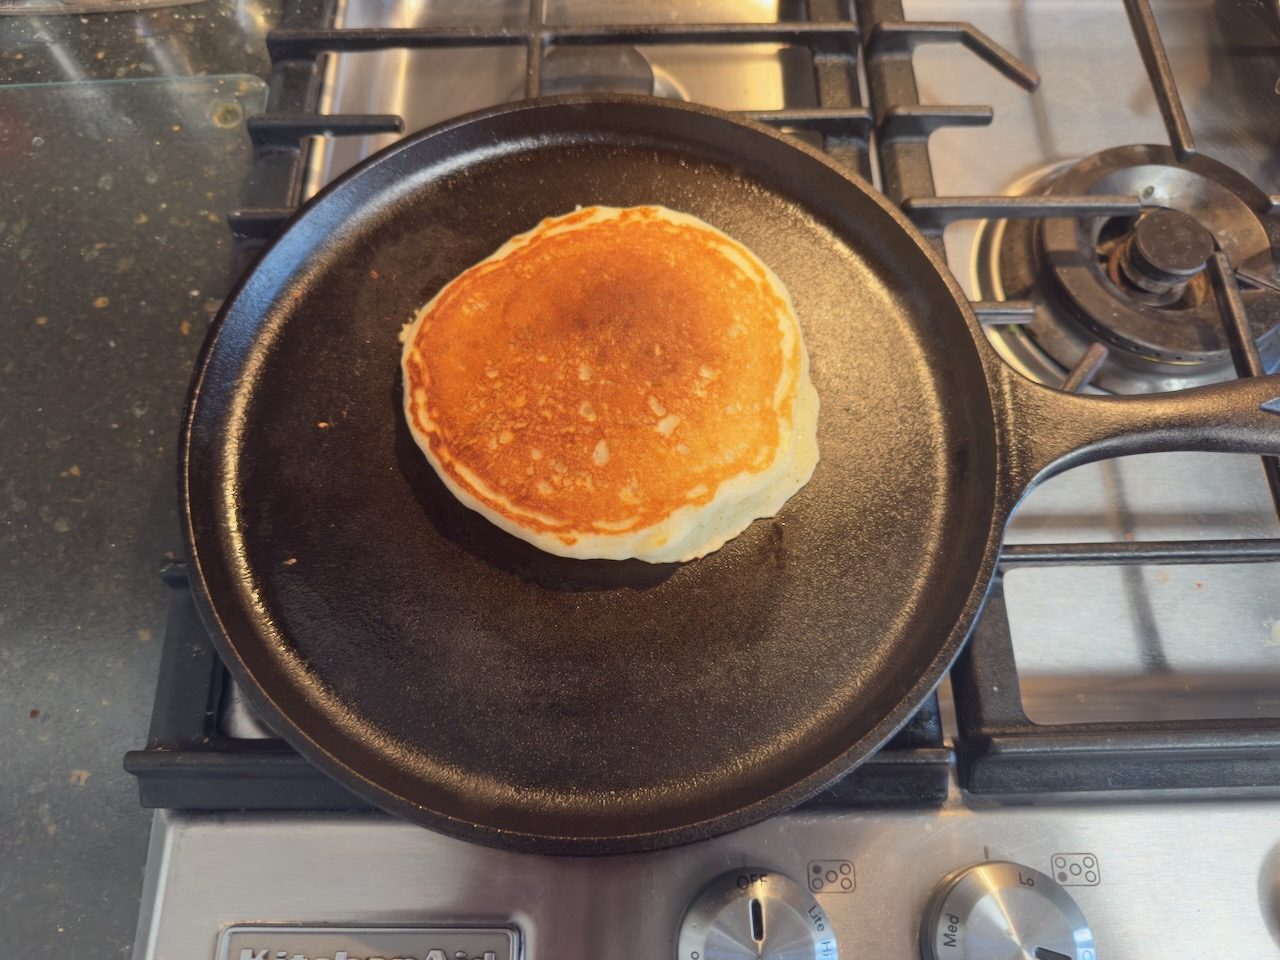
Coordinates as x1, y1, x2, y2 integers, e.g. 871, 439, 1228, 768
856, 0, 1280, 797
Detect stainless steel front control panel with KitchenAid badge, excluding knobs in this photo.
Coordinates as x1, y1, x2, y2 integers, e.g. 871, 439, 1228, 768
138, 803, 1280, 960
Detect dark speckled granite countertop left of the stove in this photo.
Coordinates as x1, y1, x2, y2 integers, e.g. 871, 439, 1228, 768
0, 0, 278, 957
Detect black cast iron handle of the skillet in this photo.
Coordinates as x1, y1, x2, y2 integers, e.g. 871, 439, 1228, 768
996, 364, 1280, 500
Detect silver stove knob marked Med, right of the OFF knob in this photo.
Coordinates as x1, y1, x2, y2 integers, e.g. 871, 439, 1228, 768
920, 860, 1097, 960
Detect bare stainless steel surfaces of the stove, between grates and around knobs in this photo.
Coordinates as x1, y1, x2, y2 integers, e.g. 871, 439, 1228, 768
136, 0, 1280, 960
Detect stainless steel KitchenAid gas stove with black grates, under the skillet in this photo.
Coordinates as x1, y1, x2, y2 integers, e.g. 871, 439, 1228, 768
125, 0, 1280, 960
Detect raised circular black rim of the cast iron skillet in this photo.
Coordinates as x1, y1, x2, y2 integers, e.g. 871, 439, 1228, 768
178, 95, 1012, 855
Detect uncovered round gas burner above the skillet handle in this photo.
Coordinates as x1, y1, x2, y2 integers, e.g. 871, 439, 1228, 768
974, 145, 1280, 393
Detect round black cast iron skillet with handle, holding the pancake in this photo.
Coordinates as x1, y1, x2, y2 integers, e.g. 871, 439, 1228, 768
182, 97, 1280, 854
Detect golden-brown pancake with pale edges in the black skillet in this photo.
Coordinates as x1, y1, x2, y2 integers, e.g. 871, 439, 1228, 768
401, 206, 818, 563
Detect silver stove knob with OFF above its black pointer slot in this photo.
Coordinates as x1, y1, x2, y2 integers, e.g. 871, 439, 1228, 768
676, 867, 840, 960
